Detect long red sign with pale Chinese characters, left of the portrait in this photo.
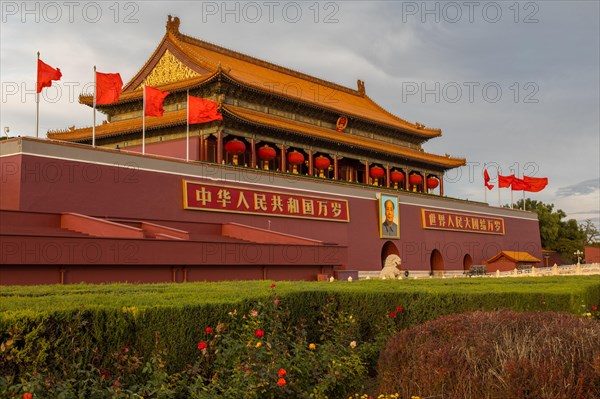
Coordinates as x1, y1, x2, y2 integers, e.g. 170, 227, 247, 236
183, 180, 350, 222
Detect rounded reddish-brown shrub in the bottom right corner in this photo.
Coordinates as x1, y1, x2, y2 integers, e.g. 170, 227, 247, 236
378, 311, 600, 399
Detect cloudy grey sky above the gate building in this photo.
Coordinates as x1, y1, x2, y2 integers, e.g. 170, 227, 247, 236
0, 0, 600, 225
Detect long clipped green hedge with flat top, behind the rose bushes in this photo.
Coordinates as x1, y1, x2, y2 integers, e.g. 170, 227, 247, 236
0, 276, 600, 377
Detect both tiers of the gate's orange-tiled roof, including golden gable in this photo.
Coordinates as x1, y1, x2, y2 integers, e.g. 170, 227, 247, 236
48, 16, 465, 168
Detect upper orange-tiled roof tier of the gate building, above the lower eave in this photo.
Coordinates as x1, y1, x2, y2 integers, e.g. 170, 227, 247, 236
80, 18, 442, 138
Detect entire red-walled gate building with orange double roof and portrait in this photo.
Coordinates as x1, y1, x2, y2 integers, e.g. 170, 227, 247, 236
0, 16, 542, 284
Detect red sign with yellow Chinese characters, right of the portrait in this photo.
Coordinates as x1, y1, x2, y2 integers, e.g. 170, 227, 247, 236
421, 208, 504, 235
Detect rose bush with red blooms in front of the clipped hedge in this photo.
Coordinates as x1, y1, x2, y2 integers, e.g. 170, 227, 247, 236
189, 291, 366, 399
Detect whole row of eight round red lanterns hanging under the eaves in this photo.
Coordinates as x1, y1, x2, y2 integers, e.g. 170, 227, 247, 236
225, 138, 439, 189
